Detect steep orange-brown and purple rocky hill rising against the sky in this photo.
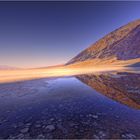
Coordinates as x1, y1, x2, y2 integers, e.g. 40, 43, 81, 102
66, 19, 140, 66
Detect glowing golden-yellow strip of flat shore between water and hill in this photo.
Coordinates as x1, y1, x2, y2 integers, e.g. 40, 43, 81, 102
0, 65, 140, 84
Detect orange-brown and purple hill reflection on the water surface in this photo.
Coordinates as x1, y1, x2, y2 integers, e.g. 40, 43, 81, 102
77, 73, 140, 109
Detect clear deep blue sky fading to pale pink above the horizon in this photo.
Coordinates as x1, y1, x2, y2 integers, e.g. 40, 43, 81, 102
0, 1, 140, 68
